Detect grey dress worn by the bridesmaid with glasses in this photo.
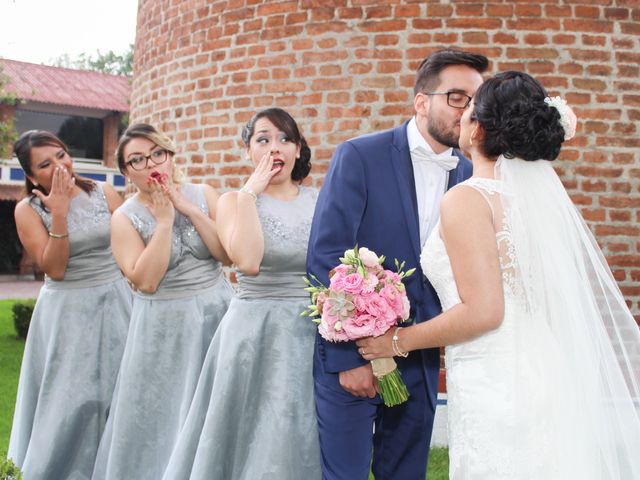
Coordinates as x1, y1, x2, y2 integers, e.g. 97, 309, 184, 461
93, 184, 233, 480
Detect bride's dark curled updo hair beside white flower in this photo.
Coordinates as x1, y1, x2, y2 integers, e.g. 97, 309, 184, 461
471, 71, 565, 161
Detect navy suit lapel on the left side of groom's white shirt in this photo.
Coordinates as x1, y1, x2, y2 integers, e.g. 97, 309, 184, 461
391, 122, 420, 262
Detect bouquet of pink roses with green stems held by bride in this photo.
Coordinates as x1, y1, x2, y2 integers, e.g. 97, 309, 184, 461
302, 245, 415, 406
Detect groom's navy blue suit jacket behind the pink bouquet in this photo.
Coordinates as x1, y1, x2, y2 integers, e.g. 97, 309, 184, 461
307, 122, 471, 408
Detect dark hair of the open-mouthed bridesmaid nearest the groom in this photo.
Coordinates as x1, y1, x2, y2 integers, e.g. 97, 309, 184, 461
242, 107, 311, 182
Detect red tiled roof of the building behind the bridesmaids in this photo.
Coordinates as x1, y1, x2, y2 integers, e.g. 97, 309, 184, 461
0, 58, 130, 112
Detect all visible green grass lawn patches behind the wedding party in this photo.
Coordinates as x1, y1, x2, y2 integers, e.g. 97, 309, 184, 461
0, 300, 449, 480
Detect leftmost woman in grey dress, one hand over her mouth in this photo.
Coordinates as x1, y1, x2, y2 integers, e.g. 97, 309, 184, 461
8, 130, 131, 480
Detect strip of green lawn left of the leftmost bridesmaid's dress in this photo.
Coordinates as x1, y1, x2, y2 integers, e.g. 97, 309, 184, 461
0, 300, 24, 458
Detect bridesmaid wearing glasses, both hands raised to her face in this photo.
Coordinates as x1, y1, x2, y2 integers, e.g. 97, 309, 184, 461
93, 124, 232, 480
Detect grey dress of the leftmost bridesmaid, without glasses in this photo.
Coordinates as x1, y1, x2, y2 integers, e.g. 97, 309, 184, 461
8, 184, 131, 480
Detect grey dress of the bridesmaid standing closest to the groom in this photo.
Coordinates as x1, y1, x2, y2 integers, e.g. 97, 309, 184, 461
163, 187, 321, 480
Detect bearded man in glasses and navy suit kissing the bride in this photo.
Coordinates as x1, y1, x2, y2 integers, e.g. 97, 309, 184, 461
307, 50, 488, 480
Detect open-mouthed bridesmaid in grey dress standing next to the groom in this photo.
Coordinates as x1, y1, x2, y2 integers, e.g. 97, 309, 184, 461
164, 108, 321, 480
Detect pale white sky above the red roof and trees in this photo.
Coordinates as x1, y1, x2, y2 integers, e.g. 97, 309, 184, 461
0, 0, 138, 64
